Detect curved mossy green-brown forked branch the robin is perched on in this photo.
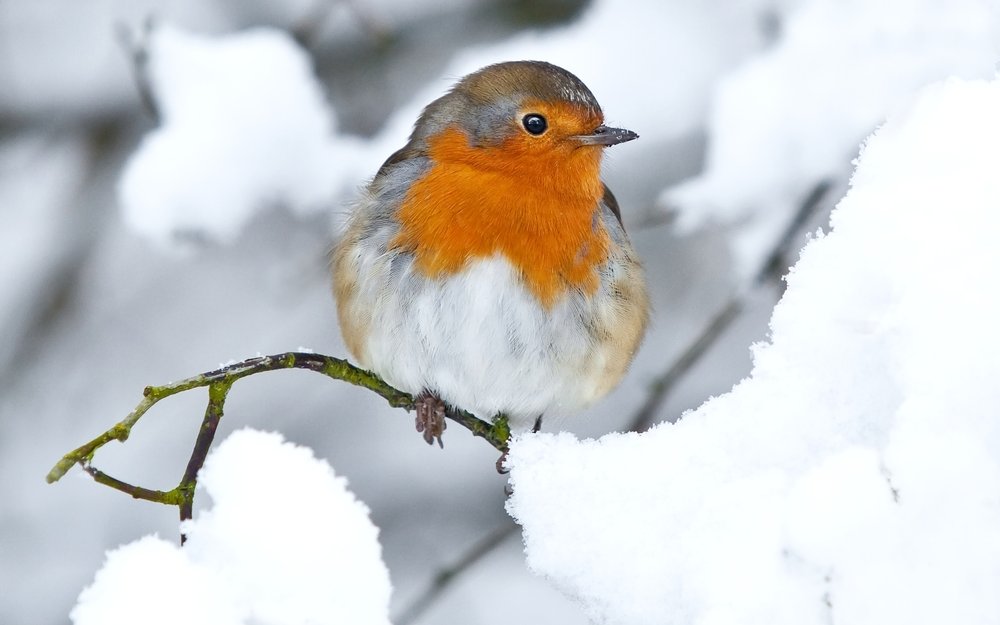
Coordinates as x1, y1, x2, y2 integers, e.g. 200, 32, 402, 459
45, 352, 510, 520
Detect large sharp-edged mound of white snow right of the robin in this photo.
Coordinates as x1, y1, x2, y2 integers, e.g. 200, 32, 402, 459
508, 80, 1000, 625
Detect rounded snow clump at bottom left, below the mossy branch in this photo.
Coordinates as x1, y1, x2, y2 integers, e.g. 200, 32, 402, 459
71, 429, 391, 625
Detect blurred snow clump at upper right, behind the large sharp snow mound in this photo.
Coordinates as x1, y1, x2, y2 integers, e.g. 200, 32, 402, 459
660, 0, 1000, 275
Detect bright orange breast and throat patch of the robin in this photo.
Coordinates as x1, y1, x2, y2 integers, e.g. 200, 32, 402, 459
392, 128, 610, 307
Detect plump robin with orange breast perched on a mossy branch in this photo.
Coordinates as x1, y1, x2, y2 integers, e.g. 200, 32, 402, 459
332, 61, 649, 446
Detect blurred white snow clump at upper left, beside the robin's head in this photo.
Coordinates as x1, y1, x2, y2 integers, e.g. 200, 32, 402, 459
119, 26, 360, 245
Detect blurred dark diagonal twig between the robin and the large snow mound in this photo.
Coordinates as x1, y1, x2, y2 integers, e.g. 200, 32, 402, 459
629, 180, 832, 432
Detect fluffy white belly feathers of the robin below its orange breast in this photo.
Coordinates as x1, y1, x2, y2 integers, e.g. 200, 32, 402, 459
361, 257, 604, 427
